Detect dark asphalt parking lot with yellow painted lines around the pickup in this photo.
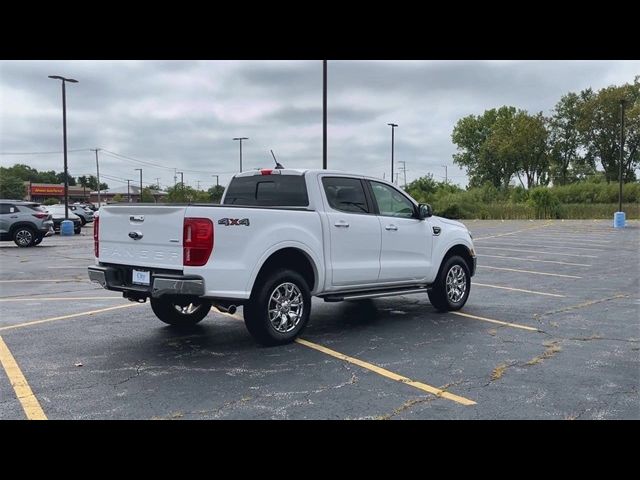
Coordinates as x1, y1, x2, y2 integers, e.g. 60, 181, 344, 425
0, 220, 640, 419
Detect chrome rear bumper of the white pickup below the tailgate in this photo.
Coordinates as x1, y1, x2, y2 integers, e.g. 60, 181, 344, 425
87, 265, 204, 297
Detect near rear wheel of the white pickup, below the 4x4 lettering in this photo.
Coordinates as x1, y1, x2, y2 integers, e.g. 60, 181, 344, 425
244, 269, 311, 346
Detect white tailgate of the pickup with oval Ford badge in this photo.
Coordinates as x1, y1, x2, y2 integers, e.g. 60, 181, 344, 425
98, 205, 186, 270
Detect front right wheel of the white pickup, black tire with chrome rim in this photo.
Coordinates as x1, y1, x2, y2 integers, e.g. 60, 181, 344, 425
428, 255, 471, 312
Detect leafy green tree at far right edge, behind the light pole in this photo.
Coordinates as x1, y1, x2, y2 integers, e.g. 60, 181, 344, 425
578, 77, 640, 181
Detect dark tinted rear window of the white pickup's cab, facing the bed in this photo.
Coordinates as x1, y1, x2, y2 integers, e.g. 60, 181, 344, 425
224, 175, 309, 207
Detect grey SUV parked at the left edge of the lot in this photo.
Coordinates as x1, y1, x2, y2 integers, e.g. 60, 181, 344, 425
0, 200, 53, 247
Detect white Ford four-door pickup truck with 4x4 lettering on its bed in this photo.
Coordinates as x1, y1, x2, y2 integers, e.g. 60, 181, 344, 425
89, 169, 476, 345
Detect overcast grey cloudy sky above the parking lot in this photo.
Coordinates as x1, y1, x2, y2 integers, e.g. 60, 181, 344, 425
0, 60, 640, 188
